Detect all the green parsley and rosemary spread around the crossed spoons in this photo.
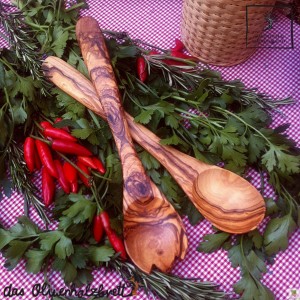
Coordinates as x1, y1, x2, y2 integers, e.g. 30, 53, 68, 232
0, 0, 300, 299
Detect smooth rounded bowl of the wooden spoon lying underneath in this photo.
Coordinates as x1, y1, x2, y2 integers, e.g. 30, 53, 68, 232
193, 167, 265, 234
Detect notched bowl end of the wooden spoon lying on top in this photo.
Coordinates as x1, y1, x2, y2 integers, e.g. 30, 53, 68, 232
124, 198, 185, 271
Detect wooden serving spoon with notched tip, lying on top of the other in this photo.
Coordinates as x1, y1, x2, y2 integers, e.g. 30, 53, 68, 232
76, 17, 188, 273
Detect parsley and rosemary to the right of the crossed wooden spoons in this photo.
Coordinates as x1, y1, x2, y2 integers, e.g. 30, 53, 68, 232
98, 30, 300, 299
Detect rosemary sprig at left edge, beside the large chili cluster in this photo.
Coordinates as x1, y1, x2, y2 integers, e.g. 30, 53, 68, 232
7, 140, 50, 225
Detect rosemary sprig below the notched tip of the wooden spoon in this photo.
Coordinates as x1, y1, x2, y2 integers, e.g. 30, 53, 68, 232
108, 260, 228, 300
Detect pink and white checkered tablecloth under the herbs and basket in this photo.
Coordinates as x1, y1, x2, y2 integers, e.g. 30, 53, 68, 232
0, 0, 300, 300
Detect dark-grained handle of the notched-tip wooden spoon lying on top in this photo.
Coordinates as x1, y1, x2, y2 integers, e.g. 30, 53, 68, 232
76, 17, 150, 198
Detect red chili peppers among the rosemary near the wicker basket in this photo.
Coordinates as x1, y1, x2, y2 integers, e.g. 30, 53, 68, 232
136, 39, 198, 82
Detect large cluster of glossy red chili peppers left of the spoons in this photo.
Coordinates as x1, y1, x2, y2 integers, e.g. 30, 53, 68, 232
24, 118, 105, 207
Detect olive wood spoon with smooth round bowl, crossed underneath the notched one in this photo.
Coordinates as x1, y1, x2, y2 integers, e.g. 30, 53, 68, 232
43, 56, 265, 234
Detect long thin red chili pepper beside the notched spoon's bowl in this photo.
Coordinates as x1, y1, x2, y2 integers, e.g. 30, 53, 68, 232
99, 211, 127, 260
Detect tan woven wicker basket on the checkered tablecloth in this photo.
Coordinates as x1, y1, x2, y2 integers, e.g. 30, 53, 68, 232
181, 0, 276, 66
